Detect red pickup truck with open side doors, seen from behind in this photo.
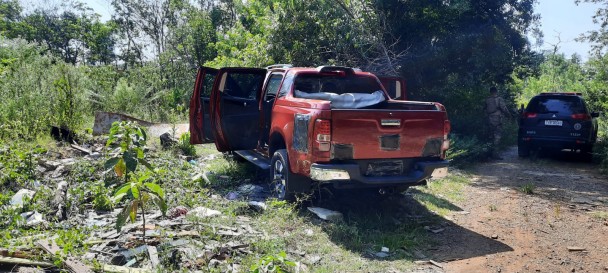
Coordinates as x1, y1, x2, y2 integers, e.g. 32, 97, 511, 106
190, 65, 450, 199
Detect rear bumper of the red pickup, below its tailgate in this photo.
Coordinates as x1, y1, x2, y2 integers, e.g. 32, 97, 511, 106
310, 160, 449, 188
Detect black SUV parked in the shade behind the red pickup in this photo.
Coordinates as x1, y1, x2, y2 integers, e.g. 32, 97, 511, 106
517, 93, 599, 159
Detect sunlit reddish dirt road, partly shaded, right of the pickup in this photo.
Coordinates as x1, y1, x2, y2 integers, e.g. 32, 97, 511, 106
429, 148, 608, 272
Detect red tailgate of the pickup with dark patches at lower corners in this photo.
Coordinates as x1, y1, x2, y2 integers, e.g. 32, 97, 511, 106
331, 104, 446, 160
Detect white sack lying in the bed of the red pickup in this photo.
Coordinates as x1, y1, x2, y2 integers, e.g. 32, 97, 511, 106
295, 90, 386, 109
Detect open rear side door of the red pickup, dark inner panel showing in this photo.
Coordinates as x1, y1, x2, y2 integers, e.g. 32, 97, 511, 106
211, 68, 266, 152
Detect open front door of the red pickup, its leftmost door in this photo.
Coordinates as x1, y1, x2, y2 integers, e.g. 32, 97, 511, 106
190, 67, 218, 144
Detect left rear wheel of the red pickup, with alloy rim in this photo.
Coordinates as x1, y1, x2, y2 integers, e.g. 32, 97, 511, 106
270, 149, 295, 201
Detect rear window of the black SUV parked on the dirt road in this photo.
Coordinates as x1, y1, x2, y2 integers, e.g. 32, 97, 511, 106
526, 96, 587, 115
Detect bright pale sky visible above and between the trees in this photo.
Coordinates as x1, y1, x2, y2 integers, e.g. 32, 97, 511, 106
21, 0, 600, 60
